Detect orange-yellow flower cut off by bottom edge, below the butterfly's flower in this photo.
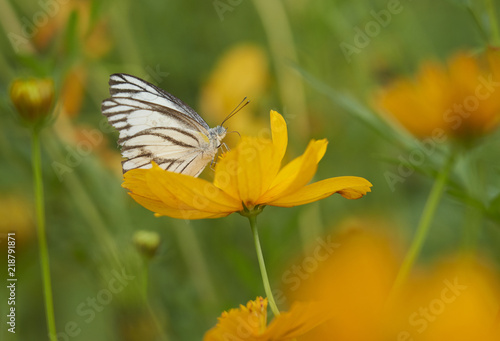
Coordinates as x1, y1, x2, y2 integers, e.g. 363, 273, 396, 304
203, 297, 326, 341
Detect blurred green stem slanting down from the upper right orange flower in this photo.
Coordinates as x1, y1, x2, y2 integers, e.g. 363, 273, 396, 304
393, 154, 454, 292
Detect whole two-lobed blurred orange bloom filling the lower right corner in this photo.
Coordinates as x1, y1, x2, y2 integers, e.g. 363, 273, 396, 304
287, 229, 500, 341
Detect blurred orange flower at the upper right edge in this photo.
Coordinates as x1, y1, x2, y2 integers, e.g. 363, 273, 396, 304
376, 50, 500, 139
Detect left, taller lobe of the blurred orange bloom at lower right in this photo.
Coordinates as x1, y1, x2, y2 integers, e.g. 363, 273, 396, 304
287, 228, 398, 341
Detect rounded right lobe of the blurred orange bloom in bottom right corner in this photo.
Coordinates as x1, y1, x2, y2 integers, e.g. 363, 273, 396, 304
386, 256, 500, 341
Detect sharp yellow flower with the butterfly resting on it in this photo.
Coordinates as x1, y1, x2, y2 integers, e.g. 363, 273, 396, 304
122, 111, 372, 219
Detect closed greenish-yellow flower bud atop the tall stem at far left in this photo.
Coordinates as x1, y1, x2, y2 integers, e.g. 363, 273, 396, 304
10, 78, 55, 122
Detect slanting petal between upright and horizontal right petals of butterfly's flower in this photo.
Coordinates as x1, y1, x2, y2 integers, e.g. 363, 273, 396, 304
257, 139, 328, 204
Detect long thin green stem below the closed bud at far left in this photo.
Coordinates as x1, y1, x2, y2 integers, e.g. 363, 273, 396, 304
32, 128, 57, 341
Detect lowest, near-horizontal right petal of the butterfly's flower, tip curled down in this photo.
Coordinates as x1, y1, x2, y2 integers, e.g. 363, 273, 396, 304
268, 176, 372, 207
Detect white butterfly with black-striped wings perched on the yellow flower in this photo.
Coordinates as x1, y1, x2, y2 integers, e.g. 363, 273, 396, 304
101, 73, 231, 177
